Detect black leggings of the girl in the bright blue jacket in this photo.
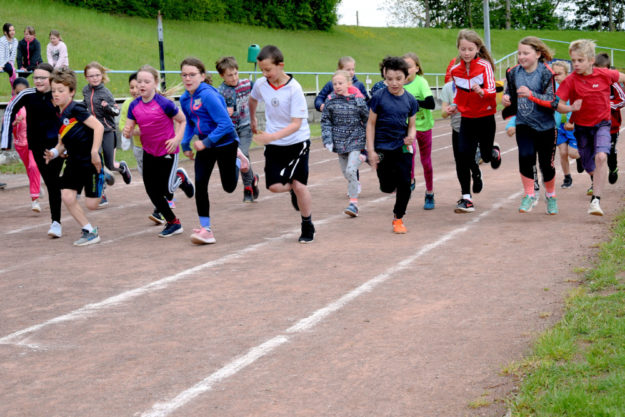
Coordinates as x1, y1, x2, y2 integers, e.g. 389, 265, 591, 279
195, 142, 239, 217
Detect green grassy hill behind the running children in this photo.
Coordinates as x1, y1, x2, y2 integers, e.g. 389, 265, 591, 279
0, 0, 625, 100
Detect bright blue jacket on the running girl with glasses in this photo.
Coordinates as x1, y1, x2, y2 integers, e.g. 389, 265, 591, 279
180, 83, 239, 151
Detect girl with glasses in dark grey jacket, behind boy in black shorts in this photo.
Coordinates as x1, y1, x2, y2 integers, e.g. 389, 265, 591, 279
82, 61, 132, 208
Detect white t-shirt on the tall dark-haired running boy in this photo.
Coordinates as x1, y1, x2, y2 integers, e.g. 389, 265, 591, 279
251, 76, 310, 146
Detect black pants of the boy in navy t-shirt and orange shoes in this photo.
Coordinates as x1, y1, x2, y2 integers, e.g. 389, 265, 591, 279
376, 147, 412, 219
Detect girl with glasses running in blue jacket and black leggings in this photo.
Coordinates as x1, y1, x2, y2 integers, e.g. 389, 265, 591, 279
180, 57, 249, 245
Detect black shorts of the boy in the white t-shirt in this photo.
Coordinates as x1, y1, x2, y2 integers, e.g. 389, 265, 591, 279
265, 140, 310, 188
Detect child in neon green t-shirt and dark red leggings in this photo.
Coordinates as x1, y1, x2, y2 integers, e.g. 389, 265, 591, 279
403, 52, 436, 210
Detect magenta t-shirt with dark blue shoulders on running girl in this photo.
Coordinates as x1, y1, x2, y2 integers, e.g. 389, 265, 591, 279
128, 94, 179, 156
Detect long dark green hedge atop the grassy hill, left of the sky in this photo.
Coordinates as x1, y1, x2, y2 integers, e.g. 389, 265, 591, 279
62, 0, 339, 31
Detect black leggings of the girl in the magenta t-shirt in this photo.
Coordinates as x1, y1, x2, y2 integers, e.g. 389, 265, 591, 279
143, 150, 180, 222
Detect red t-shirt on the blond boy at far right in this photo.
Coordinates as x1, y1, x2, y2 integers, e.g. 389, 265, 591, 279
556, 68, 619, 127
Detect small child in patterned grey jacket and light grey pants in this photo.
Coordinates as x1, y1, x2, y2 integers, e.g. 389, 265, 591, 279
321, 70, 369, 217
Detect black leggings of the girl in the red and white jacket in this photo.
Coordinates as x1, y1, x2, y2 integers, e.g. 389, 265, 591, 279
456, 115, 496, 195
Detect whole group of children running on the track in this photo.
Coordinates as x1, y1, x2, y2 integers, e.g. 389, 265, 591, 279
2, 30, 625, 246
